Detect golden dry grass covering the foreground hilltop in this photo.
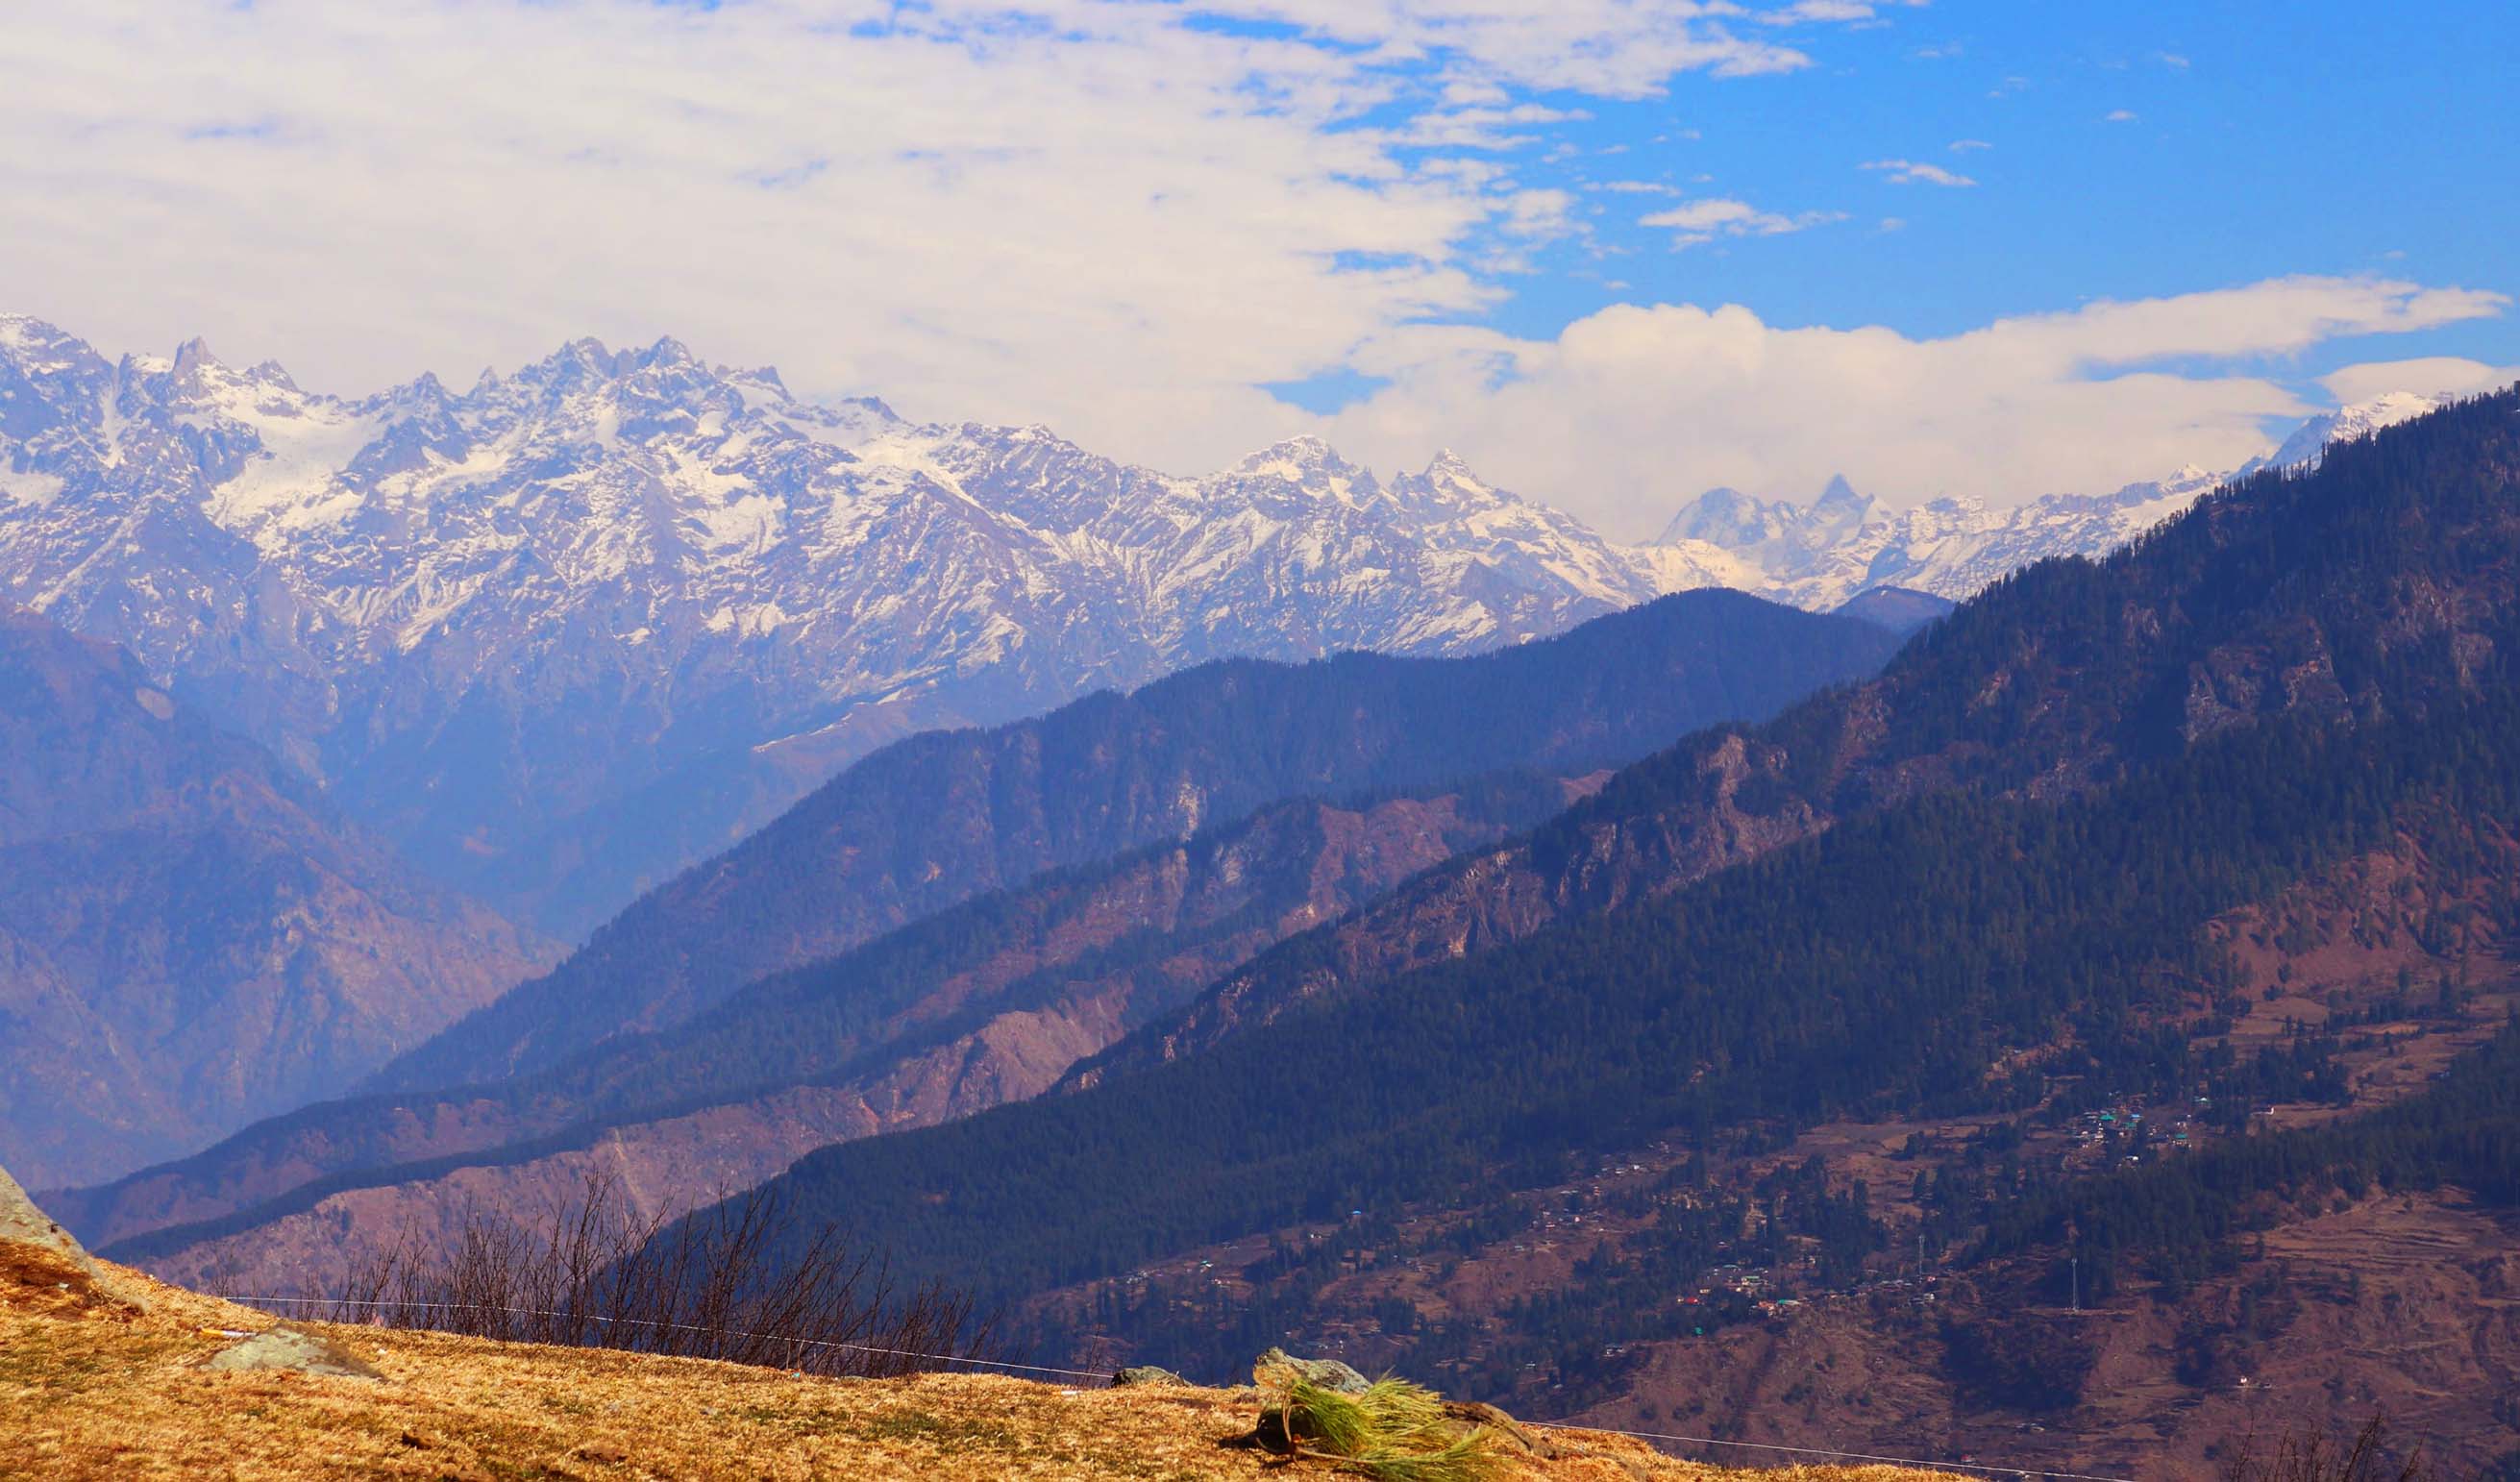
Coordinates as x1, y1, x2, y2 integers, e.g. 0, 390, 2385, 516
0, 1245, 1965, 1482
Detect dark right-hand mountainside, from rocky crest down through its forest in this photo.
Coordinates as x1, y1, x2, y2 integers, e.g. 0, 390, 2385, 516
685, 390, 2520, 1353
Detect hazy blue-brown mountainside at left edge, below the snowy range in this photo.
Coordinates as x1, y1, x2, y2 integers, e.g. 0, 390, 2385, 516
0, 607, 550, 1185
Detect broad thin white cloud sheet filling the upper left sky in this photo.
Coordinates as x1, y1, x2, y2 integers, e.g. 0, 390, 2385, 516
0, 0, 1905, 466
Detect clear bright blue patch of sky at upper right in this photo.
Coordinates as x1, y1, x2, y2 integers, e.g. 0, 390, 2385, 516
1441, 0, 2520, 371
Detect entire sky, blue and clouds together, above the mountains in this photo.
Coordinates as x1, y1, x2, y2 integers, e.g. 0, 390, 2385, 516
0, 0, 2520, 534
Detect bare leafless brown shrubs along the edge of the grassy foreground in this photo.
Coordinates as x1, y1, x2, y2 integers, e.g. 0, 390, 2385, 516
307, 1174, 996, 1378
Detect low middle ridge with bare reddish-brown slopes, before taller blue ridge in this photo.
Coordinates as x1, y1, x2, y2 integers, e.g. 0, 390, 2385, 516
88, 784, 1588, 1291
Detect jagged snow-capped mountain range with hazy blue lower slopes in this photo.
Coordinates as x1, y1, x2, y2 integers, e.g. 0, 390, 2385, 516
0, 315, 2411, 932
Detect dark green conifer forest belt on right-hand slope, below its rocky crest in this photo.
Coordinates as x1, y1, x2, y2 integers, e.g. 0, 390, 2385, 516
735, 696, 2520, 1296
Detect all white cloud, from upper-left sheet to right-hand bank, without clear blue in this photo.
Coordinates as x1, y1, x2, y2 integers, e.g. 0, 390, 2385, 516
0, 0, 2500, 531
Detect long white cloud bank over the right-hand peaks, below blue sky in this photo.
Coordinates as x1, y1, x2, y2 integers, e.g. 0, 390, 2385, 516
1325, 277, 2508, 537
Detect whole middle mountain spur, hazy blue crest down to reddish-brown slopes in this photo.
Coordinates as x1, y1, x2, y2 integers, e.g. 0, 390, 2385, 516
63, 592, 1897, 1250
